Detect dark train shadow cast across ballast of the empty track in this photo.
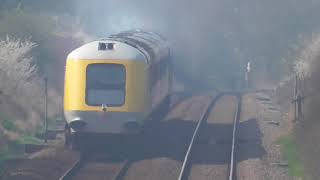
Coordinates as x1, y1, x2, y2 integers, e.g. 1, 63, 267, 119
87, 119, 265, 165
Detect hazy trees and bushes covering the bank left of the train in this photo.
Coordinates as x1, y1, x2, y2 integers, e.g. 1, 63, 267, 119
0, 7, 86, 146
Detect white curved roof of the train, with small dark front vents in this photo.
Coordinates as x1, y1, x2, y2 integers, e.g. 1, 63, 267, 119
68, 30, 170, 63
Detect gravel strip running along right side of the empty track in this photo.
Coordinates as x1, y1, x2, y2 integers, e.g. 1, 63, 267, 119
237, 94, 291, 180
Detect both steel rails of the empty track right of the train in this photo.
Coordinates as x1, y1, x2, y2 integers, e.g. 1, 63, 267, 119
178, 93, 242, 180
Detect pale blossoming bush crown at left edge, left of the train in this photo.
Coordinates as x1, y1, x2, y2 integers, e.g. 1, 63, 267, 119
0, 37, 37, 94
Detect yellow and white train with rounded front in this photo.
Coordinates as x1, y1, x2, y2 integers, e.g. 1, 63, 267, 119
64, 31, 172, 148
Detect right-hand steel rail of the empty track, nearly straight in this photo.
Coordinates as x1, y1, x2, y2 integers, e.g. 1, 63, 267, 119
229, 95, 242, 180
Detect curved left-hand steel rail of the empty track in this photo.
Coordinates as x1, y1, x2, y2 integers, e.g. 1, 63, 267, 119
178, 93, 224, 180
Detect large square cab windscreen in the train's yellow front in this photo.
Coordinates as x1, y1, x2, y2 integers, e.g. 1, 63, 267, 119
86, 64, 126, 106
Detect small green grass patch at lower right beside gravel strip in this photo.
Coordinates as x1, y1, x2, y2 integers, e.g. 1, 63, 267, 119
277, 136, 305, 178
